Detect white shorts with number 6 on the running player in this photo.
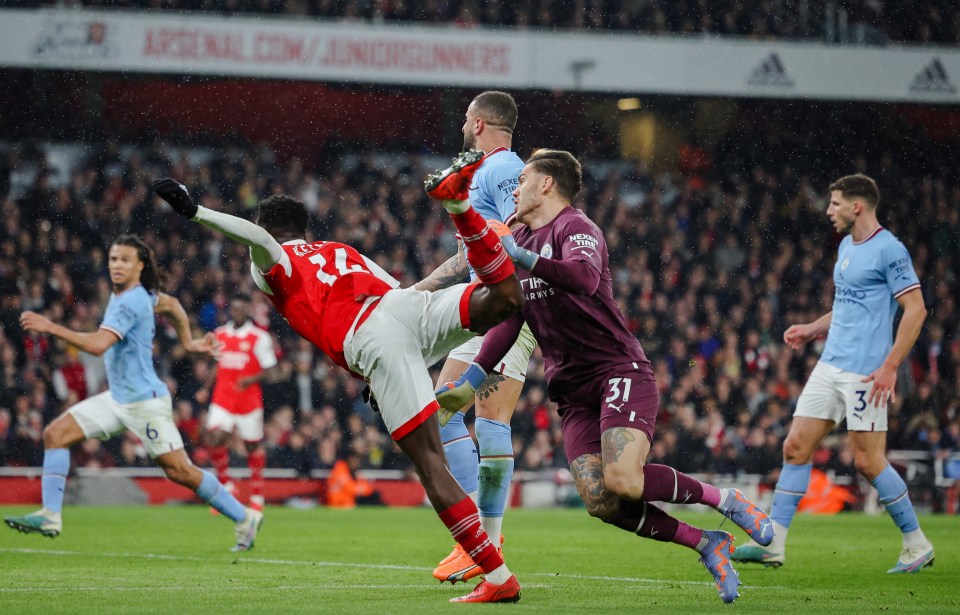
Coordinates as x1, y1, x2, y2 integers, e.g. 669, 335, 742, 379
67, 391, 183, 457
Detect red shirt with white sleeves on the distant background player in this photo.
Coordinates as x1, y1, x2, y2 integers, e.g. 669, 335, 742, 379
211, 320, 277, 414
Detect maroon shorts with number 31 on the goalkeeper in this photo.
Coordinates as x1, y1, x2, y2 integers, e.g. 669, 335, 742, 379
558, 364, 660, 463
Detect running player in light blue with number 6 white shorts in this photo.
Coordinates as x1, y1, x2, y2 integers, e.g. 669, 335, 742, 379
5, 235, 263, 551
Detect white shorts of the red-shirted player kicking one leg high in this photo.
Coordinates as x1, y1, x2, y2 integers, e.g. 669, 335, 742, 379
343, 284, 475, 440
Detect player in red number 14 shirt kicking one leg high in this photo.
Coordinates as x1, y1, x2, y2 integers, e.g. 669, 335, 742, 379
153, 151, 523, 602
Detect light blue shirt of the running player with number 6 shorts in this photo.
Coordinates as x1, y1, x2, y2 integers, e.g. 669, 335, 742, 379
100, 284, 170, 404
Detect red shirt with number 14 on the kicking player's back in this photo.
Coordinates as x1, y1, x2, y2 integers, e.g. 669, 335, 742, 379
252, 240, 400, 370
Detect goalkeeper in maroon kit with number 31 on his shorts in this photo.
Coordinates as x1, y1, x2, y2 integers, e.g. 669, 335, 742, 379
437, 150, 773, 602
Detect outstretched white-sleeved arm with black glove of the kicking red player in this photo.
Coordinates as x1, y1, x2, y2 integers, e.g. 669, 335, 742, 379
151, 177, 283, 271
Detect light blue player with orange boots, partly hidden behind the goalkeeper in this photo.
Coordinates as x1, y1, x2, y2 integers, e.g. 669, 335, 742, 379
416, 91, 536, 583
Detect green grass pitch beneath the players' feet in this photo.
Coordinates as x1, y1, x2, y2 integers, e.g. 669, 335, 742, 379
0, 506, 960, 615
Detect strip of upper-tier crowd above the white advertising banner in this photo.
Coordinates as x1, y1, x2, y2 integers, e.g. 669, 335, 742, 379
0, 0, 960, 44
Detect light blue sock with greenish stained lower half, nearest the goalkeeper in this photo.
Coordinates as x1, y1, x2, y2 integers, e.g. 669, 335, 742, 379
475, 418, 513, 544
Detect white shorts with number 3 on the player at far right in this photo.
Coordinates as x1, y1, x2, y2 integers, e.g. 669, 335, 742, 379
793, 362, 887, 431
